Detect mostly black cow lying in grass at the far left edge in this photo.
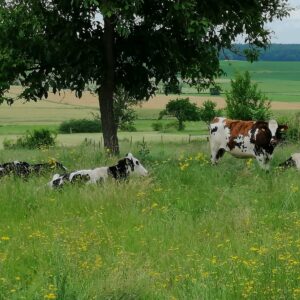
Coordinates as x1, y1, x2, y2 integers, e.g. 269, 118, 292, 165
0, 160, 67, 177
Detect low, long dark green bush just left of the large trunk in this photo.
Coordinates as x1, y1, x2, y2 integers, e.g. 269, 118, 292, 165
58, 119, 102, 133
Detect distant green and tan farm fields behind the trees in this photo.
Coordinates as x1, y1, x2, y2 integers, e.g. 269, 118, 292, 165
0, 61, 300, 134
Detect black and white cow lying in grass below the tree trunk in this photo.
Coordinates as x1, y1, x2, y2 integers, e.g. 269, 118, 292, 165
48, 153, 148, 187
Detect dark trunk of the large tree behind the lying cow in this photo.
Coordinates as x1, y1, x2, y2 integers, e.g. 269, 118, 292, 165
99, 17, 119, 155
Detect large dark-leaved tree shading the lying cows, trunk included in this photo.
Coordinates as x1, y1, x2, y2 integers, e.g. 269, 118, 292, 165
0, 0, 289, 153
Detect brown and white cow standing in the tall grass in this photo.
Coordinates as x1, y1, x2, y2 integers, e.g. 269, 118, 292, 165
210, 117, 287, 170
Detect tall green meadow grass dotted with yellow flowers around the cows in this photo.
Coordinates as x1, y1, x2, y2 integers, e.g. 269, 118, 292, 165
0, 141, 300, 299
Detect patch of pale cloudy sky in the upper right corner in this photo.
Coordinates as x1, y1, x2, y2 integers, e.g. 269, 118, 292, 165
266, 0, 300, 44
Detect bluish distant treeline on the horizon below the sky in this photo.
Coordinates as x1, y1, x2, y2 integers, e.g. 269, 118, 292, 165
220, 44, 300, 61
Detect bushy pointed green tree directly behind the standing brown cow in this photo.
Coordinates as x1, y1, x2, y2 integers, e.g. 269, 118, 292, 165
226, 71, 271, 120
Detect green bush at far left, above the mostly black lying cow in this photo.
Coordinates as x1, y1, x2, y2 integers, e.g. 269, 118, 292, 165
3, 129, 56, 149
